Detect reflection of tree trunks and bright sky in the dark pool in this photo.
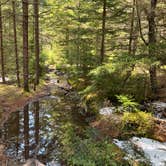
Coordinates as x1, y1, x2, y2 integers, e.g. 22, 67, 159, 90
0, 98, 61, 162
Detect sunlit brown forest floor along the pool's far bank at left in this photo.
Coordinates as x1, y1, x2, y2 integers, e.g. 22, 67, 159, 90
0, 82, 49, 110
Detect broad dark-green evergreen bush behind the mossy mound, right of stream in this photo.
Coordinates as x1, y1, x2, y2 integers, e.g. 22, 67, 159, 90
81, 63, 149, 102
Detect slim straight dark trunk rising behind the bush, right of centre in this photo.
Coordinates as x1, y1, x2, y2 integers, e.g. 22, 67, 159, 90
100, 0, 107, 64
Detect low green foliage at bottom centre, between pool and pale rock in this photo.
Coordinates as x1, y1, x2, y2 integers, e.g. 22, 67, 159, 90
62, 125, 126, 166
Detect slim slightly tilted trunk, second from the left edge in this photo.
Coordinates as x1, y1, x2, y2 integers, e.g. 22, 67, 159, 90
12, 1, 20, 87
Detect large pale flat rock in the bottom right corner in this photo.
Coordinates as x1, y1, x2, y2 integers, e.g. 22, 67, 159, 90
114, 137, 166, 166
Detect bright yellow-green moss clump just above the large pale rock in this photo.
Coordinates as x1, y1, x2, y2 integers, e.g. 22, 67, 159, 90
122, 111, 153, 136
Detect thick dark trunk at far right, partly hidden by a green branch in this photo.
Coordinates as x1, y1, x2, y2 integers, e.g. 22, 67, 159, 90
148, 0, 157, 94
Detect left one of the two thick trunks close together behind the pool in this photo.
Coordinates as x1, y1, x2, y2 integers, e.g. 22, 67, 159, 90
22, 0, 29, 91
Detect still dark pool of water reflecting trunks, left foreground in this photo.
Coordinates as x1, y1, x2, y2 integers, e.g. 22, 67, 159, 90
0, 87, 88, 166
